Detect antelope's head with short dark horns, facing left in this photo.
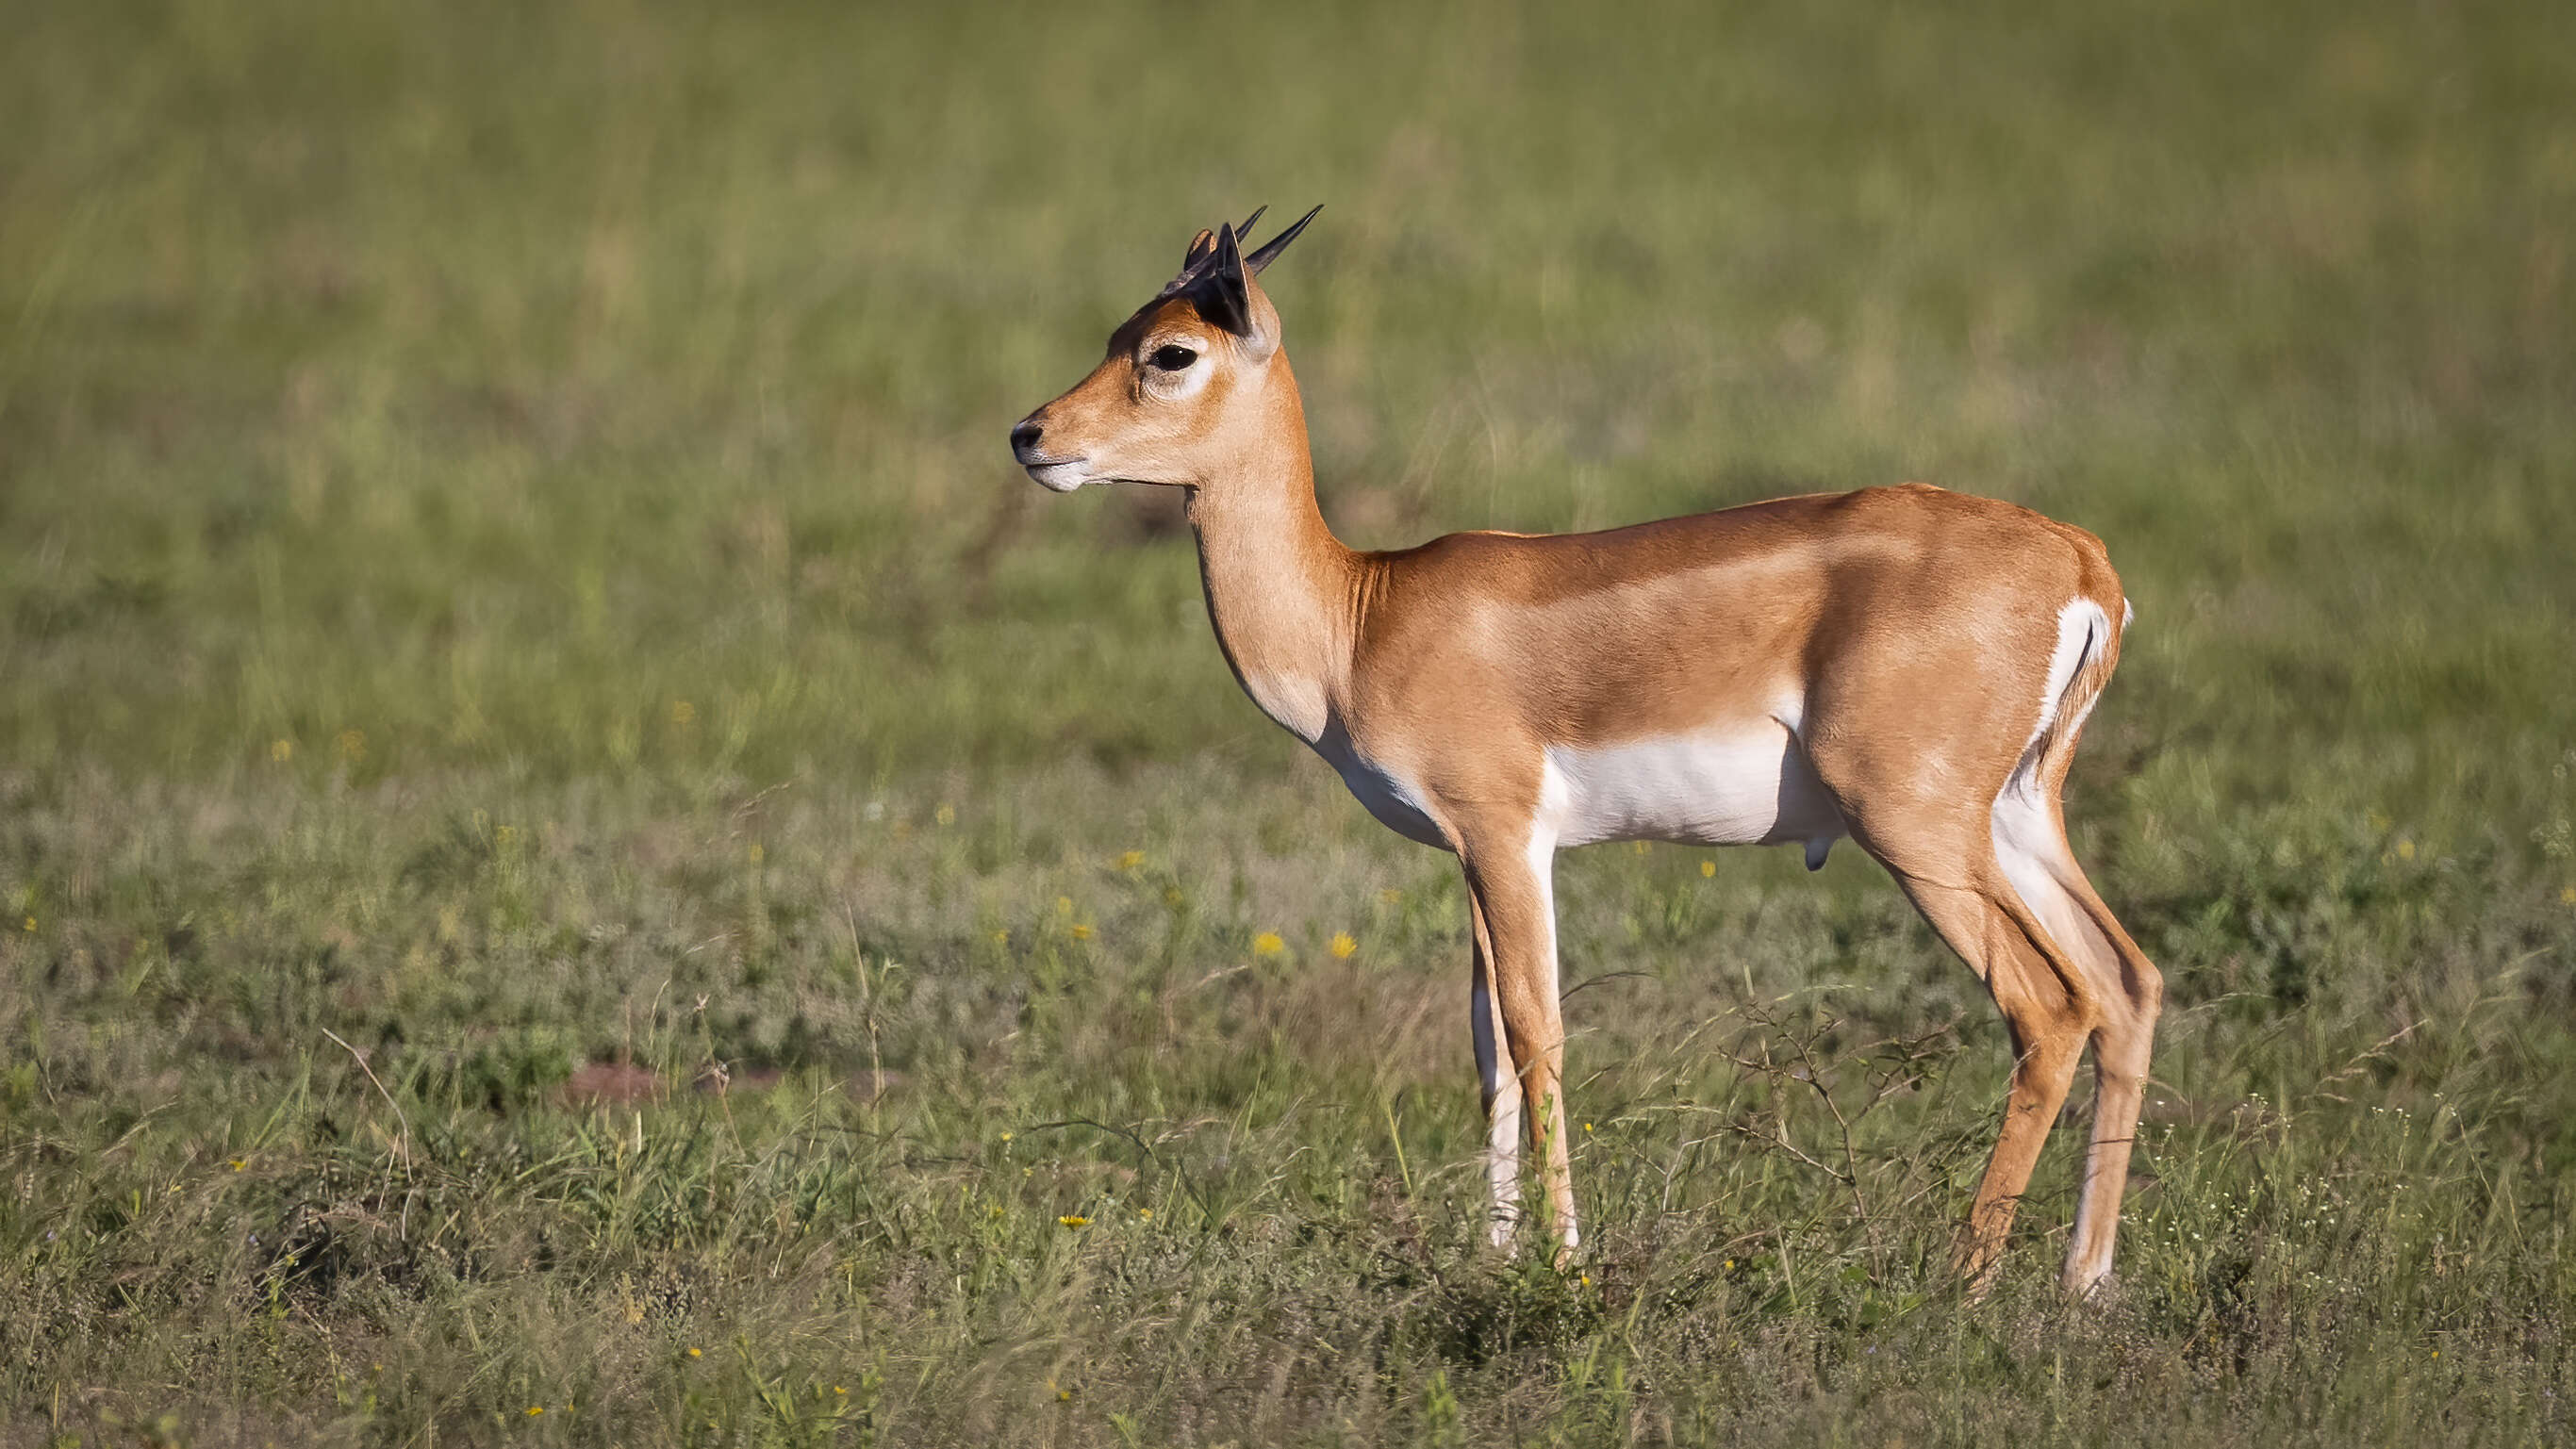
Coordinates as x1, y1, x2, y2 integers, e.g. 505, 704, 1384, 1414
1010, 206, 1322, 494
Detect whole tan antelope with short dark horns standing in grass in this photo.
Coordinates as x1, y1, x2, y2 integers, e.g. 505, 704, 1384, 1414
1010, 211, 2161, 1292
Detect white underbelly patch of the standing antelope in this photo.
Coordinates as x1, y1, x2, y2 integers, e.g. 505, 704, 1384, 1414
1541, 720, 1844, 860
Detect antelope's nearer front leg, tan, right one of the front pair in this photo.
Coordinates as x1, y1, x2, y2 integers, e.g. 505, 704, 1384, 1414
1461, 826, 1581, 1263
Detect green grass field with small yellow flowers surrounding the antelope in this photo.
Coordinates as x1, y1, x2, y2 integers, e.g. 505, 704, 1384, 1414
0, 0, 2576, 1446
